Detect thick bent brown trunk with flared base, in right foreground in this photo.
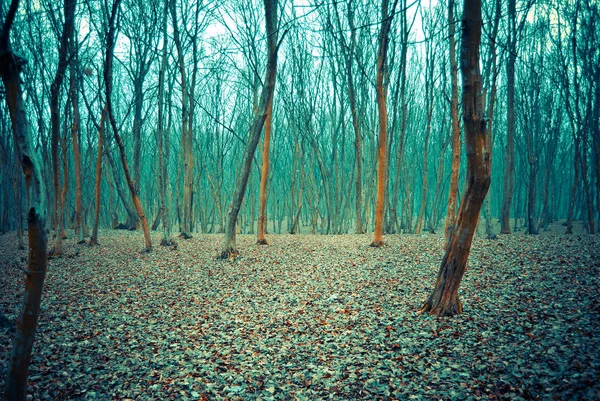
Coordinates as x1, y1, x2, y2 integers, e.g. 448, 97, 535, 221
421, 0, 491, 316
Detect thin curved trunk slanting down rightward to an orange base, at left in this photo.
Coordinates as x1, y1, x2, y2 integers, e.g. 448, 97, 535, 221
104, 0, 152, 252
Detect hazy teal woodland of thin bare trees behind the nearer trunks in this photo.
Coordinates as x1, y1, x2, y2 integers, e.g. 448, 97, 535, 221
0, 0, 600, 248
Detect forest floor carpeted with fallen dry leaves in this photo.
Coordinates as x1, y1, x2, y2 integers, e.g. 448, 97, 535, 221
0, 227, 600, 400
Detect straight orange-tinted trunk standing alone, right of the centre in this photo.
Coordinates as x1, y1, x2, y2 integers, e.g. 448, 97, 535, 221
371, 0, 397, 247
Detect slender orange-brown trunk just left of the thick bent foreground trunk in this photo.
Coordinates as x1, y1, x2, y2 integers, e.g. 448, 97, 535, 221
444, 0, 460, 240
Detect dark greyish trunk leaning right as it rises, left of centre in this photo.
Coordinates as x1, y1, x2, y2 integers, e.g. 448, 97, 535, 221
220, 0, 278, 259
